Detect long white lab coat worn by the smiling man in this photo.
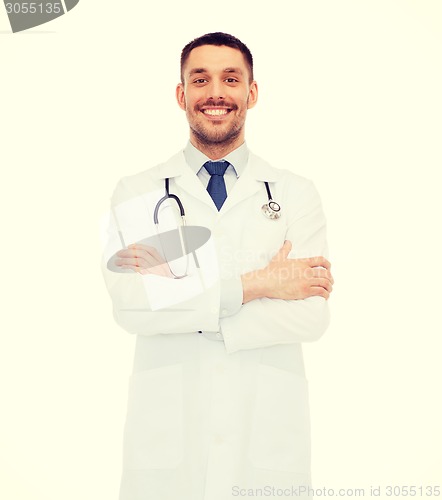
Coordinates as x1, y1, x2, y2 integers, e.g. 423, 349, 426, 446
104, 152, 329, 500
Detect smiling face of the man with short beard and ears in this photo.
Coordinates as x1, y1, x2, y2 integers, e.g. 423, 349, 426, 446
177, 45, 258, 146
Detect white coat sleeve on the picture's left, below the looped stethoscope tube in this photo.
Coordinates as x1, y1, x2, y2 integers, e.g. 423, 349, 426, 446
101, 177, 220, 335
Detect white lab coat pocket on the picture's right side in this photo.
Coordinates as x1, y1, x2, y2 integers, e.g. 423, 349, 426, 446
249, 365, 310, 473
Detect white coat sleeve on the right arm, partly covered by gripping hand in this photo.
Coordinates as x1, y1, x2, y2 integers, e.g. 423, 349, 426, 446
220, 180, 329, 352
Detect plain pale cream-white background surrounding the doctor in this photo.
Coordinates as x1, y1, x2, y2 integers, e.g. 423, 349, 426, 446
0, 0, 442, 500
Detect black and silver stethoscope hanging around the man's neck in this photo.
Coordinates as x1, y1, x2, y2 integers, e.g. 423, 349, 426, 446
153, 178, 281, 278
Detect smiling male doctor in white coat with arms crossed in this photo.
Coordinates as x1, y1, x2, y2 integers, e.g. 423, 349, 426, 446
103, 33, 333, 500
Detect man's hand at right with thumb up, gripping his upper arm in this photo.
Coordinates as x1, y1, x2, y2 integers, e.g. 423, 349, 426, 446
241, 241, 334, 304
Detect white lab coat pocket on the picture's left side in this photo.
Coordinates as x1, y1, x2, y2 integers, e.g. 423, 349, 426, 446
124, 364, 183, 469
